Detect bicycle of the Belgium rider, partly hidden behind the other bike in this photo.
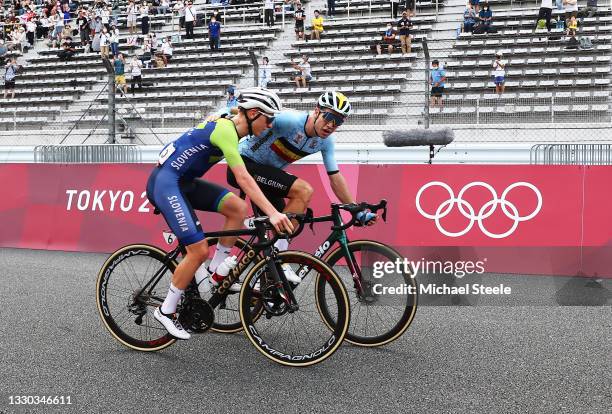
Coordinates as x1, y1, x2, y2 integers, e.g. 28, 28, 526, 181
203, 200, 418, 347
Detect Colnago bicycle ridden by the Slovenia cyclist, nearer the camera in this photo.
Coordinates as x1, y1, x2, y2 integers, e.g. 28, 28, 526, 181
96, 215, 350, 367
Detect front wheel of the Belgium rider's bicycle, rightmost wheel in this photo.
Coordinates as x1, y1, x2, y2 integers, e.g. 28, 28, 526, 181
317, 240, 418, 347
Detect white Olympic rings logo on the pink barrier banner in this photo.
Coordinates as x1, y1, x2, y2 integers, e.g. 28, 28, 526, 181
416, 181, 542, 239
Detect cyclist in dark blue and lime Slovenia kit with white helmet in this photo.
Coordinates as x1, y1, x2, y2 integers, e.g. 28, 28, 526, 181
147, 88, 293, 339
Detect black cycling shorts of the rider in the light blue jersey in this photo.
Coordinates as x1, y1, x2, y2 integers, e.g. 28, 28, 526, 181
227, 156, 297, 211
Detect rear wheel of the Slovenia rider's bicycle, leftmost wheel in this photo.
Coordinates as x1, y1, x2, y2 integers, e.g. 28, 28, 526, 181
96, 244, 177, 352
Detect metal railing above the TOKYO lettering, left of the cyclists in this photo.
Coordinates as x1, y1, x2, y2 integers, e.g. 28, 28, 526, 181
34, 144, 142, 164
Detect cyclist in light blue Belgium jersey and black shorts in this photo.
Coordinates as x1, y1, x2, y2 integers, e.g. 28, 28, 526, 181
208, 91, 377, 283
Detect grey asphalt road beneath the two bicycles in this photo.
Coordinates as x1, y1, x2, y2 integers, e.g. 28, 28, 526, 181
0, 249, 612, 414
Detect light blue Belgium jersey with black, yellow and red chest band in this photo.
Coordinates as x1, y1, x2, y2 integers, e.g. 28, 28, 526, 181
239, 111, 338, 174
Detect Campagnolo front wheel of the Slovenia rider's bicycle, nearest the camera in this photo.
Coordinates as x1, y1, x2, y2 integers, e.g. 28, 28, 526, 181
240, 251, 349, 367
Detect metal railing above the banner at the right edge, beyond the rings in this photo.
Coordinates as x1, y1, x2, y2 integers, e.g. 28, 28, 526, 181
529, 144, 612, 165
